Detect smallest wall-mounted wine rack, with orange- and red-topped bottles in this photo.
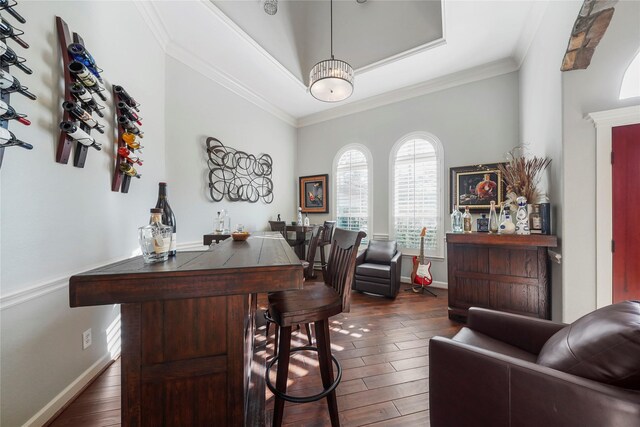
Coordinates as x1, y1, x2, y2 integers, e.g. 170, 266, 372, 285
111, 85, 143, 193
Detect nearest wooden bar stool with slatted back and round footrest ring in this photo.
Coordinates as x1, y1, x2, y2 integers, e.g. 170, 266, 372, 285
266, 229, 366, 427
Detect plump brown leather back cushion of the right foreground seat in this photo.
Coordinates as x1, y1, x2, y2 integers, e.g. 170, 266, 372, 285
538, 301, 640, 390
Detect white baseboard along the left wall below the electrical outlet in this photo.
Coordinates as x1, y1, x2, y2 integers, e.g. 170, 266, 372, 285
22, 354, 113, 427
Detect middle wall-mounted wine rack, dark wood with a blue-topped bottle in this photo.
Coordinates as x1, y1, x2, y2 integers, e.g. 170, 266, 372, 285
56, 16, 107, 168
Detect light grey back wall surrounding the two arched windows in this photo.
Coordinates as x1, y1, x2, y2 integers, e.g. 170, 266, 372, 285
297, 73, 520, 282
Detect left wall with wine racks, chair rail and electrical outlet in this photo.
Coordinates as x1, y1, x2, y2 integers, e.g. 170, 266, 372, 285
0, 1, 165, 426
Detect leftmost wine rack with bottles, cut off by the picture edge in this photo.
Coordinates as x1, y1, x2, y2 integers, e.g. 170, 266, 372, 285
0, 0, 36, 172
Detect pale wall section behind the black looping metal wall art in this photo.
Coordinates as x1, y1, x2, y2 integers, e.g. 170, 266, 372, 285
166, 57, 296, 243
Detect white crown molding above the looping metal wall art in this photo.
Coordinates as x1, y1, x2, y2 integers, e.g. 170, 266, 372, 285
166, 42, 297, 127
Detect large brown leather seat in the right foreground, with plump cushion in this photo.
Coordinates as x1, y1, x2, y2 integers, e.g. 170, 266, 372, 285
429, 301, 640, 427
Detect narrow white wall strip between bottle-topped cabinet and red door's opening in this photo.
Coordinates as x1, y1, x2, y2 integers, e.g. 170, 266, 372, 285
520, 1, 582, 321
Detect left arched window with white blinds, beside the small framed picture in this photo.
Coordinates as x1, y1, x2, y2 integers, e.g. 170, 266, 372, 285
333, 144, 371, 241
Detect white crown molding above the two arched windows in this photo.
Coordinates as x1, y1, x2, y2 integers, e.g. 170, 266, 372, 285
297, 58, 519, 128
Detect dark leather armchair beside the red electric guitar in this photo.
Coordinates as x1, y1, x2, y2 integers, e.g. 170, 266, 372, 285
352, 240, 402, 298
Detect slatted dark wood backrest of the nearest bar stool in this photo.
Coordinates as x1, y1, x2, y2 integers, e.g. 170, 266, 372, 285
324, 228, 367, 313
